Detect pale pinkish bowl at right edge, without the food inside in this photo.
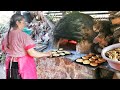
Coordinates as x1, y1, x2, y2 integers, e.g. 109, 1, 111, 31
101, 43, 120, 71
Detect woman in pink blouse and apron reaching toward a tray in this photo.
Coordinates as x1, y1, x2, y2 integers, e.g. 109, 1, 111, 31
2, 14, 51, 79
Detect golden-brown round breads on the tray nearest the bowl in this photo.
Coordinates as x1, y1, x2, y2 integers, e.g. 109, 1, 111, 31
75, 53, 106, 66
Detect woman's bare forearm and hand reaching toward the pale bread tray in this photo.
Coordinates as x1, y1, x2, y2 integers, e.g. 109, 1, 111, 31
27, 48, 52, 58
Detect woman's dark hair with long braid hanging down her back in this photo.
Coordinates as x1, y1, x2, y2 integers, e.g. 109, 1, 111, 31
7, 13, 24, 48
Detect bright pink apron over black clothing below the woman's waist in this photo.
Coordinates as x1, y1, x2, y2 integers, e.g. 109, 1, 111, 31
5, 55, 37, 79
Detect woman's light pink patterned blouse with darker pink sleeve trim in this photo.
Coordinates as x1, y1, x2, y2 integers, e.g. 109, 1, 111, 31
2, 30, 35, 57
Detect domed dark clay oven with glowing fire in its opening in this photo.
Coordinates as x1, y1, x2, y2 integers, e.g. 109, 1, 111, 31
53, 11, 95, 51
